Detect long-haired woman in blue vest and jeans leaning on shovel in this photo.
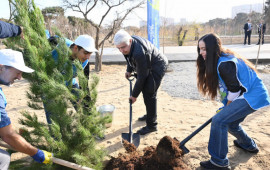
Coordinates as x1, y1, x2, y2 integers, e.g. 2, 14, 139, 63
197, 34, 270, 169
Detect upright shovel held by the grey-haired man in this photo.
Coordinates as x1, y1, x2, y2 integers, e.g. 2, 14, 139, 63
122, 75, 140, 148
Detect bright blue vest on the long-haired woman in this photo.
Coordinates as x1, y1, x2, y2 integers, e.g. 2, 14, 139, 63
217, 54, 270, 110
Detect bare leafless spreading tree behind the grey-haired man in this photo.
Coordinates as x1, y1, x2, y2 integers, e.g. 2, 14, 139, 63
63, 0, 145, 71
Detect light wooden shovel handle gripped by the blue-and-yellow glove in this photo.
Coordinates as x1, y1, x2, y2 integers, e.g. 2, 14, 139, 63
0, 141, 94, 170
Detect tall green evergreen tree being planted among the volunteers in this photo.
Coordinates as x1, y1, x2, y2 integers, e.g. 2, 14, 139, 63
6, 0, 111, 169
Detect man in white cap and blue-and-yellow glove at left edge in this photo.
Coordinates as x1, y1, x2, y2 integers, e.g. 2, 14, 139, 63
0, 49, 53, 170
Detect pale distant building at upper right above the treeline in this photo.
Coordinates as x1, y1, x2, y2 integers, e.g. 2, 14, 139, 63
232, 4, 263, 18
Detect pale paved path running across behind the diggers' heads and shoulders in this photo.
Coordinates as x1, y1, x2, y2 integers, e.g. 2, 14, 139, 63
90, 44, 270, 64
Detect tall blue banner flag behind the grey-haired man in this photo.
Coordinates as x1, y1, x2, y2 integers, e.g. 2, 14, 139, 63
147, 0, 159, 49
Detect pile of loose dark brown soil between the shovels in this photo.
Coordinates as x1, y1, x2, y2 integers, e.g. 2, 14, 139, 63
104, 136, 190, 170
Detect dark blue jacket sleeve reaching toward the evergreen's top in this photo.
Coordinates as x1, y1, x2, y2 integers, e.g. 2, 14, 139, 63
0, 21, 22, 38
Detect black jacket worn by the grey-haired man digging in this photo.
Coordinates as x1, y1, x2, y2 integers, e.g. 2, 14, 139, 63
125, 36, 168, 97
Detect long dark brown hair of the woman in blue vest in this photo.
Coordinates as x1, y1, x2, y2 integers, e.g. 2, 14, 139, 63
197, 33, 256, 99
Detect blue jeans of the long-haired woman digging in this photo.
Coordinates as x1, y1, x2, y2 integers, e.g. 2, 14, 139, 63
208, 99, 257, 166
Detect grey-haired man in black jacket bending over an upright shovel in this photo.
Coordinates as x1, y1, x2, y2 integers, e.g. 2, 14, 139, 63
114, 30, 168, 135
